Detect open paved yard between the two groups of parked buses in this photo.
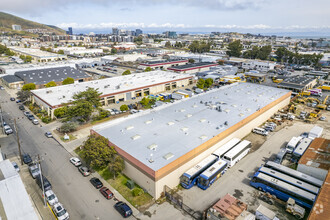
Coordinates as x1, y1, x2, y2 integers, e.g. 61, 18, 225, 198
179, 111, 330, 219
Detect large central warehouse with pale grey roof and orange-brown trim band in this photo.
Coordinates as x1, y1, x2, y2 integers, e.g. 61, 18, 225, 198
91, 83, 291, 198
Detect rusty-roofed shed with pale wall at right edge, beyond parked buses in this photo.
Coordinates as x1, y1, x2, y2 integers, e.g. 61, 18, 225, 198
297, 138, 330, 180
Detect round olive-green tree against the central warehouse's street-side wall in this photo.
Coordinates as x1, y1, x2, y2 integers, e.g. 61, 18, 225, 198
81, 135, 117, 168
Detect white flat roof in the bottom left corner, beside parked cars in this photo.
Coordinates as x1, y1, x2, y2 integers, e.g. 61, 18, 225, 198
0, 160, 38, 220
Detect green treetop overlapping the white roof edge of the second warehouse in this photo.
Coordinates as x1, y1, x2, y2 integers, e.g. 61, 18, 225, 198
72, 88, 102, 107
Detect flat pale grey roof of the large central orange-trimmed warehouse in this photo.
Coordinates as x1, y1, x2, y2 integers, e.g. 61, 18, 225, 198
93, 83, 289, 171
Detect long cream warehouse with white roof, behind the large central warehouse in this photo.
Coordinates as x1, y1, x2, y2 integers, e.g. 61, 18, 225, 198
31, 70, 193, 118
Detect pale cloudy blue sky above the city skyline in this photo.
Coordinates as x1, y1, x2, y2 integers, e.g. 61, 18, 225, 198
0, 0, 330, 36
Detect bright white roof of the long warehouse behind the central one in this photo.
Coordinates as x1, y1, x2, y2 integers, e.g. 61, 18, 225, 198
32, 70, 192, 106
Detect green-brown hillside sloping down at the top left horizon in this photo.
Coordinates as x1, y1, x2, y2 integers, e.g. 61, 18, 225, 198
0, 12, 65, 34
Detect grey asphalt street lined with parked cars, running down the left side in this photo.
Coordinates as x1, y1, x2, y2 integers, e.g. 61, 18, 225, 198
0, 90, 133, 220
